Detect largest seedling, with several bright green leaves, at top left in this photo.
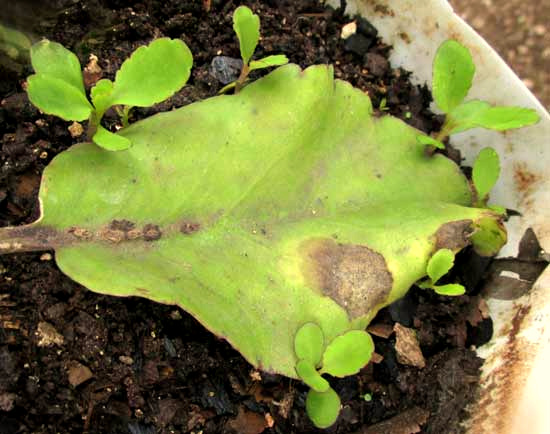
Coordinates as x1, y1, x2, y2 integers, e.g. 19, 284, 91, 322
27, 38, 193, 151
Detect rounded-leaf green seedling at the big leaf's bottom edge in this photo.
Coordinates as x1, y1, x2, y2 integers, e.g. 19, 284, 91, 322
294, 323, 374, 428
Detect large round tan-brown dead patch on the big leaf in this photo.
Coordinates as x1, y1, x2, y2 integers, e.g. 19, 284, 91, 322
304, 239, 393, 320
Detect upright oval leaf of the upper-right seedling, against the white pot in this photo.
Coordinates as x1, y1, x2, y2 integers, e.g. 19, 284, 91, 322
432, 40, 475, 113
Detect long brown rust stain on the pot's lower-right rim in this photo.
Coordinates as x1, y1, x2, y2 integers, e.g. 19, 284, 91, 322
469, 305, 533, 434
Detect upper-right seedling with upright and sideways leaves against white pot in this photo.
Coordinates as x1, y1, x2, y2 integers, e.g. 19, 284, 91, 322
418, 40, 539, 149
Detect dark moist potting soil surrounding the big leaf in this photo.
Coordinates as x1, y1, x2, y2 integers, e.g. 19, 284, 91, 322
0, 0, 536, 434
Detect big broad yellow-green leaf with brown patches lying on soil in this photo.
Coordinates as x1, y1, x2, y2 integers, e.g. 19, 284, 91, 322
7, 65, 498, 378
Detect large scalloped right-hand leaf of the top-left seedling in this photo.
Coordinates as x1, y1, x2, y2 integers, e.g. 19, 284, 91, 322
111, 38, 193, 107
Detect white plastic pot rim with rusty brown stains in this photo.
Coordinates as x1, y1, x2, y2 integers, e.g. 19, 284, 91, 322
328, 0, 550, 434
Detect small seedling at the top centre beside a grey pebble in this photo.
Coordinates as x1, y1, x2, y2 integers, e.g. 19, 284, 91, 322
220, 6, 288, 93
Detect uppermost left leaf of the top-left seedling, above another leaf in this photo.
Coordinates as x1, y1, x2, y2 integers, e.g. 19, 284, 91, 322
31, 39, 86, 94
